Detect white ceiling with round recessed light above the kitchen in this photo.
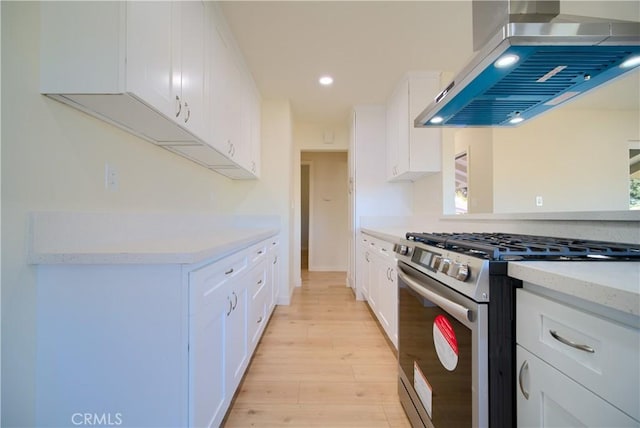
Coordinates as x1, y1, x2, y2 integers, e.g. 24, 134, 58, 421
222, 0, 640, 127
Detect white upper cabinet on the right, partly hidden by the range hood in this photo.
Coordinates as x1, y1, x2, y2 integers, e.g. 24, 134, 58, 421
386, 72, 442, 181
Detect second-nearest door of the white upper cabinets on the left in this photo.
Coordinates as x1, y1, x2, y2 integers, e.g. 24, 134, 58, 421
177, 1, 206, 139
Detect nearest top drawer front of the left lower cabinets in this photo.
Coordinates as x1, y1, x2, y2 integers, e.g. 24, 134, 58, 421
189, 251, 247, 315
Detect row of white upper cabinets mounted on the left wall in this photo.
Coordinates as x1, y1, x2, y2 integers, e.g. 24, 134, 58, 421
41, 1, 257, 178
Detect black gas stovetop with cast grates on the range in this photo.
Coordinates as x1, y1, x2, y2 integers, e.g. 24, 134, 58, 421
406, 233, 640, 261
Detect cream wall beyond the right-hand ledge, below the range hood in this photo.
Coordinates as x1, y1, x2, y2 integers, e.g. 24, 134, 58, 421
493, 110, 640, 213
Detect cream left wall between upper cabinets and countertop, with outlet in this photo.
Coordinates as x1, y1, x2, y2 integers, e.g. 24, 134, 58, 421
1, 2, 292, 427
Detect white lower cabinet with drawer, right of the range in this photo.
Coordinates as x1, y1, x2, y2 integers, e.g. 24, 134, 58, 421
516, 284, 640, 427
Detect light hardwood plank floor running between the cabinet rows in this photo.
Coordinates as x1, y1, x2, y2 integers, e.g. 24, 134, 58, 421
224, 271, 410, 428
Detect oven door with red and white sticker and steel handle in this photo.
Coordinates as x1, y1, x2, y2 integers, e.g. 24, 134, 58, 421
398, 261, 488, 428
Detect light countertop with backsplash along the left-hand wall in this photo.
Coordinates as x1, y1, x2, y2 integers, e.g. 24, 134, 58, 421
28, 213, 279, 264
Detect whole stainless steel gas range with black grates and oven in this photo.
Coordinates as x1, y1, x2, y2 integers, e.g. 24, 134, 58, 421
395, 233, 640, 428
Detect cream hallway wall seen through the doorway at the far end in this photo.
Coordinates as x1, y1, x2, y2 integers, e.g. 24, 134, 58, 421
301, 152, 348, 271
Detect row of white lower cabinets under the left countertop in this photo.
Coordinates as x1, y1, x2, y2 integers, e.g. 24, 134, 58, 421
36, 237, 278, 427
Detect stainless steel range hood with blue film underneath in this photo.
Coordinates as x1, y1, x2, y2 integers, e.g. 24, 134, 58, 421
414, 0, 640, 127
